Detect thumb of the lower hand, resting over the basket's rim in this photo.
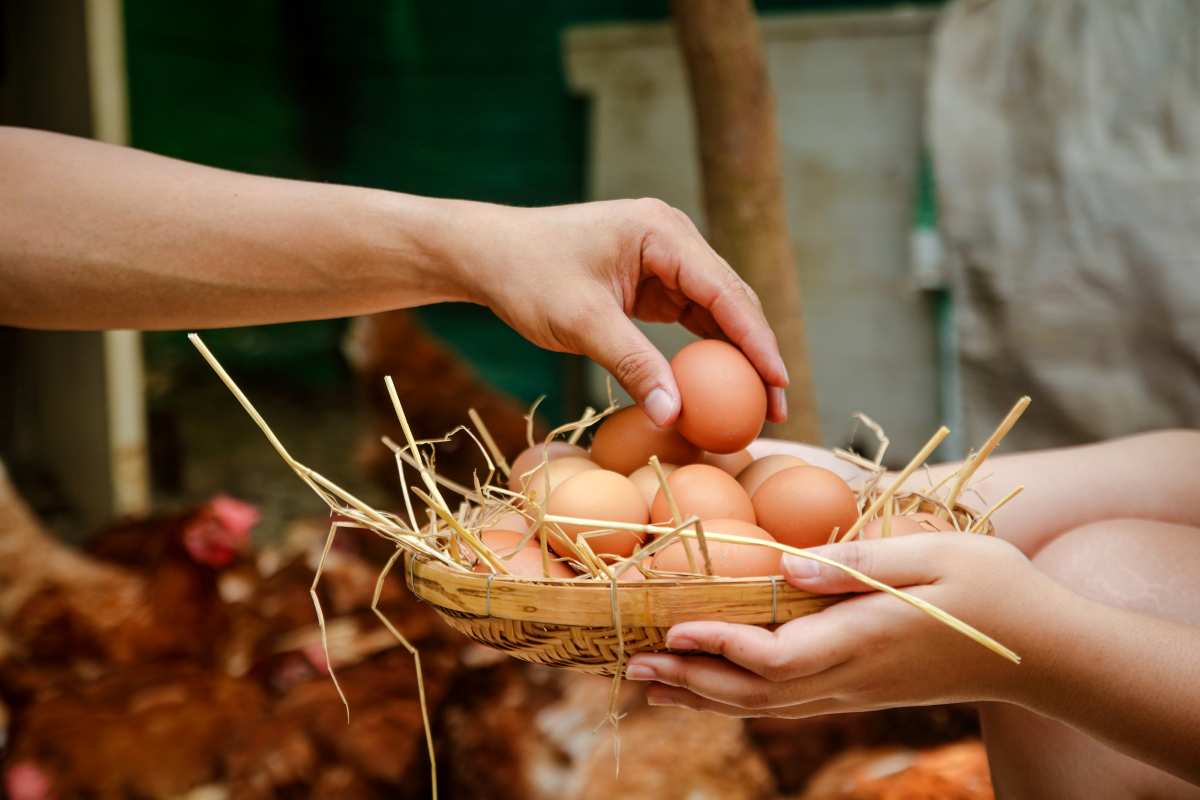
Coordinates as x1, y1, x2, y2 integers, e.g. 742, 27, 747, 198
782, 534, 947, 595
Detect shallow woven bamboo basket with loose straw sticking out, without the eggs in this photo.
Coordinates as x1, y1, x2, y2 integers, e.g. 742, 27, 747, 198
188, 333, 1030, 796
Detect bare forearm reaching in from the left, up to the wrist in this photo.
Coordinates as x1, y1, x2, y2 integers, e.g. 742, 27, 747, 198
0, 128, 464, 329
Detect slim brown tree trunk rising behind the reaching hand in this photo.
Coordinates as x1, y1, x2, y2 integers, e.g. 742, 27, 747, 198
671, 0, 821, 444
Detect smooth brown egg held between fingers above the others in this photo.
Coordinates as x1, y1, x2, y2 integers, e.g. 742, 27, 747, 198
671, 339, 767, 453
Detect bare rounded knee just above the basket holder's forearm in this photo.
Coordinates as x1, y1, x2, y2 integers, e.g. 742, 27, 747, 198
1033, 519, 1200, 624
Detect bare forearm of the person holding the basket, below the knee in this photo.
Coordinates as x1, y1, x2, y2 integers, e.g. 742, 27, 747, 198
1018, 590, 1200, 783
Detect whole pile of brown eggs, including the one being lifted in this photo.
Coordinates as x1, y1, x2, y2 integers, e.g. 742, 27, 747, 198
475, 339, 907, 579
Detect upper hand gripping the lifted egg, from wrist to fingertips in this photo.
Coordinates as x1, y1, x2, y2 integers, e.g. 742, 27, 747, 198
455, 199, 787, 427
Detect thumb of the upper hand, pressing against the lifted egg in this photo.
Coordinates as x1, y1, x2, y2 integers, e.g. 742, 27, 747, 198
582, 314, 679, 428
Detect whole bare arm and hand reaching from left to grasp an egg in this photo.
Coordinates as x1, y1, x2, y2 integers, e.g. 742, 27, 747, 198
0, 127, 787, 425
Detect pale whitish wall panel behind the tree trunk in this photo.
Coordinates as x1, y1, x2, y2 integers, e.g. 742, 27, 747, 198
565, 11, 941, 455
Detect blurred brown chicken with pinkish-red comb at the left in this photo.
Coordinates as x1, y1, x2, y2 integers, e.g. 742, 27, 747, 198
0, 493, 258, 663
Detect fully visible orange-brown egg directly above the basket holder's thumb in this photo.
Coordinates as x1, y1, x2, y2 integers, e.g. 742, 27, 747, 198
752, 467, 858, 547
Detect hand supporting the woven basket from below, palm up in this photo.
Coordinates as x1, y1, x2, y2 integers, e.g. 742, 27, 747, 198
626, 534, 1074, 717
